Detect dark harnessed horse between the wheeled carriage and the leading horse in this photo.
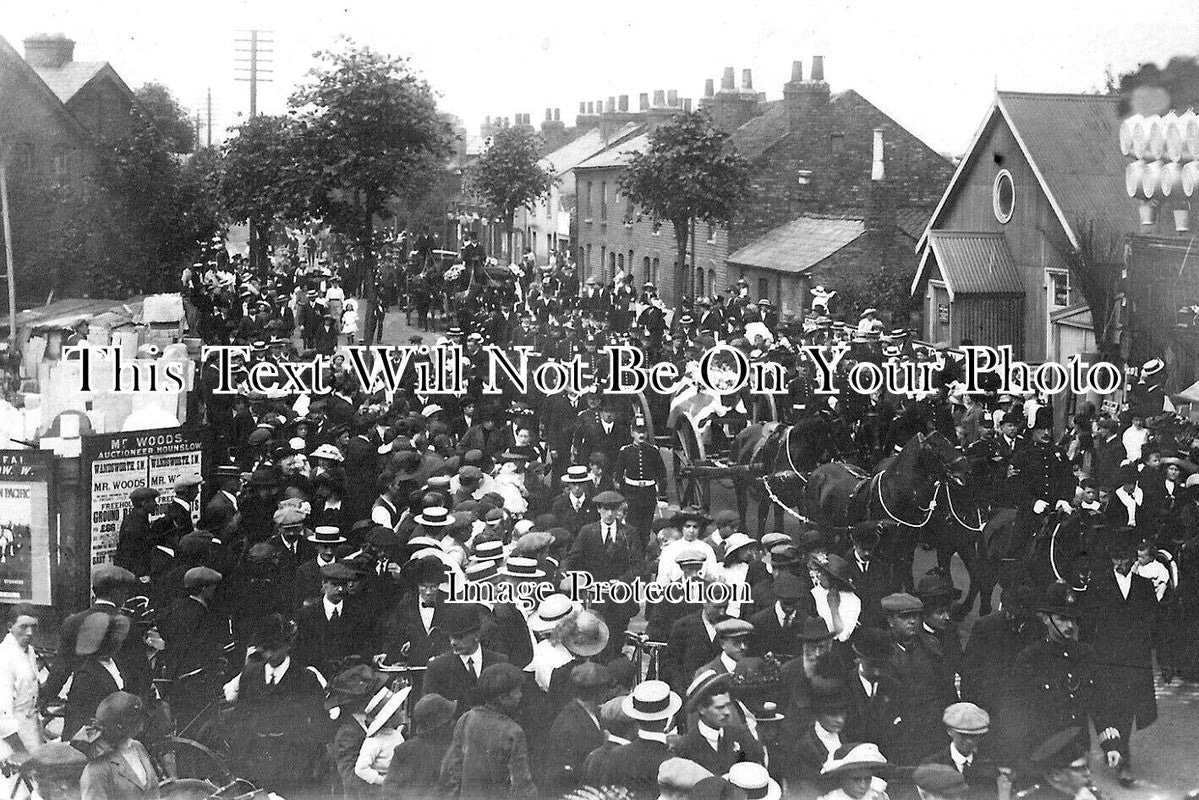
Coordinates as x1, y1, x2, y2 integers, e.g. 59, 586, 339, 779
733, 414, 854, 536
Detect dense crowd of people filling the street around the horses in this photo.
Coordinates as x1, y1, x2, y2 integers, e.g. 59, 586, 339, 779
11, 236, 1199, 800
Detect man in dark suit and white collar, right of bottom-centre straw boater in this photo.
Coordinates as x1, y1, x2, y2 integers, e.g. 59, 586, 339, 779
673, 674, 765, 775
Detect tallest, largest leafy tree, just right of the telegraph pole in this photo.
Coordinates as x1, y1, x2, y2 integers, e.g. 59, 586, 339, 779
290, 42, 451, 335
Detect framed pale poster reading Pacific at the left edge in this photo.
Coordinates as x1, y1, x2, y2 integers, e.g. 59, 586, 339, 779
0, 450, 54, 606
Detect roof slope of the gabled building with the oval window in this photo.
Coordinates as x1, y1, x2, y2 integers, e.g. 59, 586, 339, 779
998, 91, 1139, 245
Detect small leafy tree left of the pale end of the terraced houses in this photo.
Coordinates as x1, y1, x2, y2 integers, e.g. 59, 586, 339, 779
468, 127, 556, 260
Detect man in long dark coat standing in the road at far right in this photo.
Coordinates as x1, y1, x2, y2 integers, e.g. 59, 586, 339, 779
1081, 529, 1158, 786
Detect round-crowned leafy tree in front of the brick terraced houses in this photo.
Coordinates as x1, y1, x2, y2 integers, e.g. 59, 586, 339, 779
620, 110, 749, 300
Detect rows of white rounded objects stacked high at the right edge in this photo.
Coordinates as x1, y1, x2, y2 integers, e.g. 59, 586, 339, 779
1120, 110, 1199, 231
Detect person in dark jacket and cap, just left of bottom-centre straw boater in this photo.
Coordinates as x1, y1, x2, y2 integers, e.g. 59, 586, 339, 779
540, 661, 611, 796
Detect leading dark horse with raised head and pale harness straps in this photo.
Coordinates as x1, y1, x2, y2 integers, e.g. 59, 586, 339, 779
802, 433, 965, 590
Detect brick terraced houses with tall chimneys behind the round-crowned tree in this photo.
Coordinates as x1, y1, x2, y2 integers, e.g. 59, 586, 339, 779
577, 56, 952, 314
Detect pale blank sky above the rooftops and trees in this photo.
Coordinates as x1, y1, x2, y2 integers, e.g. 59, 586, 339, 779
0, 0, 1199, 155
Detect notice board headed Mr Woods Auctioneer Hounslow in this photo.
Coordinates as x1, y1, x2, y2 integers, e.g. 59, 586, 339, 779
83, 428, 205, 578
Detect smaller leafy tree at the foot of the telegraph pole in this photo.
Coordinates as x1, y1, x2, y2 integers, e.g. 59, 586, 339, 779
216, 114, 311, 264
